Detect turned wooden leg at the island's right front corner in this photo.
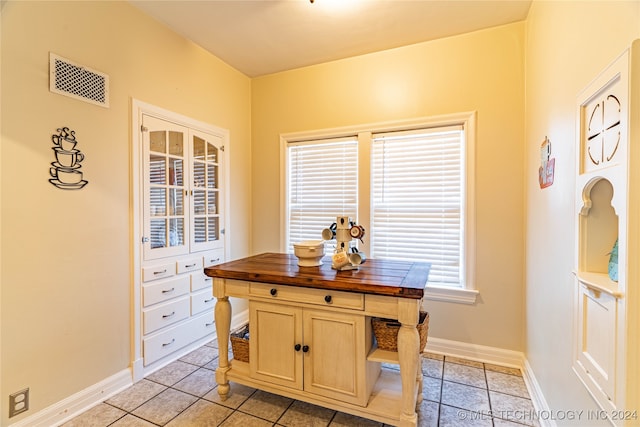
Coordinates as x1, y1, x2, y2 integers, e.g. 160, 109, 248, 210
398, 299, 420, 427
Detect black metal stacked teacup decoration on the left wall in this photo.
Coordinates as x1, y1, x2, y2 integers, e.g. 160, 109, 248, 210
49, 127, 88, 190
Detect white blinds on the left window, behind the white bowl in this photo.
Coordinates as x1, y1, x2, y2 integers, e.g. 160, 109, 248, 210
286, 137, 358, 253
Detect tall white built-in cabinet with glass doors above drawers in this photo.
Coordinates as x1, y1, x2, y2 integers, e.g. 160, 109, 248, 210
132, 102, 228, 379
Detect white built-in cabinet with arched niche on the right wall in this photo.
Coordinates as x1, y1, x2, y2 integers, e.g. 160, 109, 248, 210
573, 41, 640, 426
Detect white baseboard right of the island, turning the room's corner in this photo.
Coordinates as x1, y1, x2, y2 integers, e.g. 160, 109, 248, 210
425, 337, 556, 427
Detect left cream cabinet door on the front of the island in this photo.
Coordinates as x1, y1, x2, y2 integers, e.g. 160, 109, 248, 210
249, 301, 303, 390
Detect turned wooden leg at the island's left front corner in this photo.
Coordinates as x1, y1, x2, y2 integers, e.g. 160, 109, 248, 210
213, 279, 231, 400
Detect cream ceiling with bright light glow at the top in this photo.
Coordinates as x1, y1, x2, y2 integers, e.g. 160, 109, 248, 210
130, 0, 531, 77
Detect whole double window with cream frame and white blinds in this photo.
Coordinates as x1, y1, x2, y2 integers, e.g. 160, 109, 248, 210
282, 114, 477, 303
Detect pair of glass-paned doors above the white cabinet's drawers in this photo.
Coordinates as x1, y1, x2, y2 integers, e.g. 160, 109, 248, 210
142, 115, 224, 260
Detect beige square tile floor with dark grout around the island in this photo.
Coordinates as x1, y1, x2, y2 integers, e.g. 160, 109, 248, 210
63, 342, 539, 427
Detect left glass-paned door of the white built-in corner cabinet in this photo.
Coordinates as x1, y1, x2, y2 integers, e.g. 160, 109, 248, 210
143, 116, 189, 259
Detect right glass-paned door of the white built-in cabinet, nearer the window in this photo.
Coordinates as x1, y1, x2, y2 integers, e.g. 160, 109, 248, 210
190, 130, 224, 250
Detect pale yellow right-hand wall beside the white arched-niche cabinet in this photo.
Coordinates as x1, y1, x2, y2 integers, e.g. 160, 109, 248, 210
525, 1, 640, 416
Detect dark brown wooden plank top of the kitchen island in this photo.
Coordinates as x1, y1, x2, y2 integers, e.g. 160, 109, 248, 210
204, 253, 431, 299
